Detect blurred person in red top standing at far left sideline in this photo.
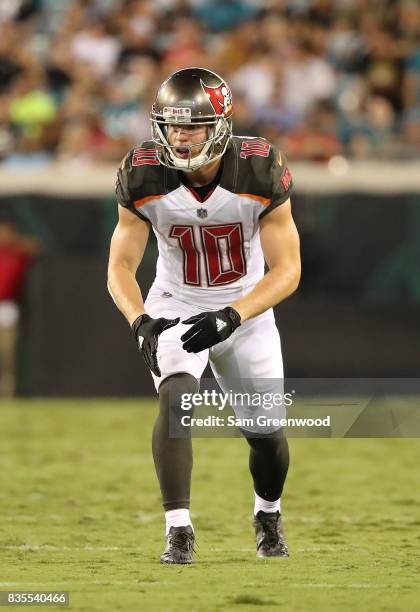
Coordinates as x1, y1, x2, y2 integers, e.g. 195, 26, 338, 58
0, 215, 40, 397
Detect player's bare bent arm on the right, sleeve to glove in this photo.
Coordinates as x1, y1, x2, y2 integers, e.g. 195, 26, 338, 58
231, 198, 301, 323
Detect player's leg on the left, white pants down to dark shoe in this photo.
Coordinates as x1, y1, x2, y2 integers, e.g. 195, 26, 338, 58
145, 290, 208, 564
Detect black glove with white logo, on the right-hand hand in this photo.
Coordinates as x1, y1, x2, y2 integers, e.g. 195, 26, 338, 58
181, 306, 241, 353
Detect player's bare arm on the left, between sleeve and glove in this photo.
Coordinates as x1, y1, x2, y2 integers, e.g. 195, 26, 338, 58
108, 205, 150, 325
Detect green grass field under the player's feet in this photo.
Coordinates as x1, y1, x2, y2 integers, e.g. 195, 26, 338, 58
0, 400, 420, 612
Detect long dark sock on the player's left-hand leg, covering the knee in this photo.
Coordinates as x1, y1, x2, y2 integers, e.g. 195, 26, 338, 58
152, 373, 199, 510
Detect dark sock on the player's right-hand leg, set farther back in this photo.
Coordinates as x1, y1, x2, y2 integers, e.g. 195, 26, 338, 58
242, 429, 289, 501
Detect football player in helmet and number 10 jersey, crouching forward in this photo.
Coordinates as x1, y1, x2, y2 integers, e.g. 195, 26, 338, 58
108, 68, 300, 563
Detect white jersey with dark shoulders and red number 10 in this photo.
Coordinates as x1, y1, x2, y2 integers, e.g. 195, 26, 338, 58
117, 136, 292, 309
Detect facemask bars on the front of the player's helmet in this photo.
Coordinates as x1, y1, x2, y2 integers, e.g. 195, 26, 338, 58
151, 111, 232, 172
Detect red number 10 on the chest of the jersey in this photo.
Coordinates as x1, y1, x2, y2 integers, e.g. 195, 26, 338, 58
169, 223, 246, 287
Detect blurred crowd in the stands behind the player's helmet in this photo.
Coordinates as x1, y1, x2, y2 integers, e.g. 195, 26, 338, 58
0, 0, 420, 167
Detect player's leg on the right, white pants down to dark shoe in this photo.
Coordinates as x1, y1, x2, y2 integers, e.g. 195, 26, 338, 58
210, 310, 289, 557
